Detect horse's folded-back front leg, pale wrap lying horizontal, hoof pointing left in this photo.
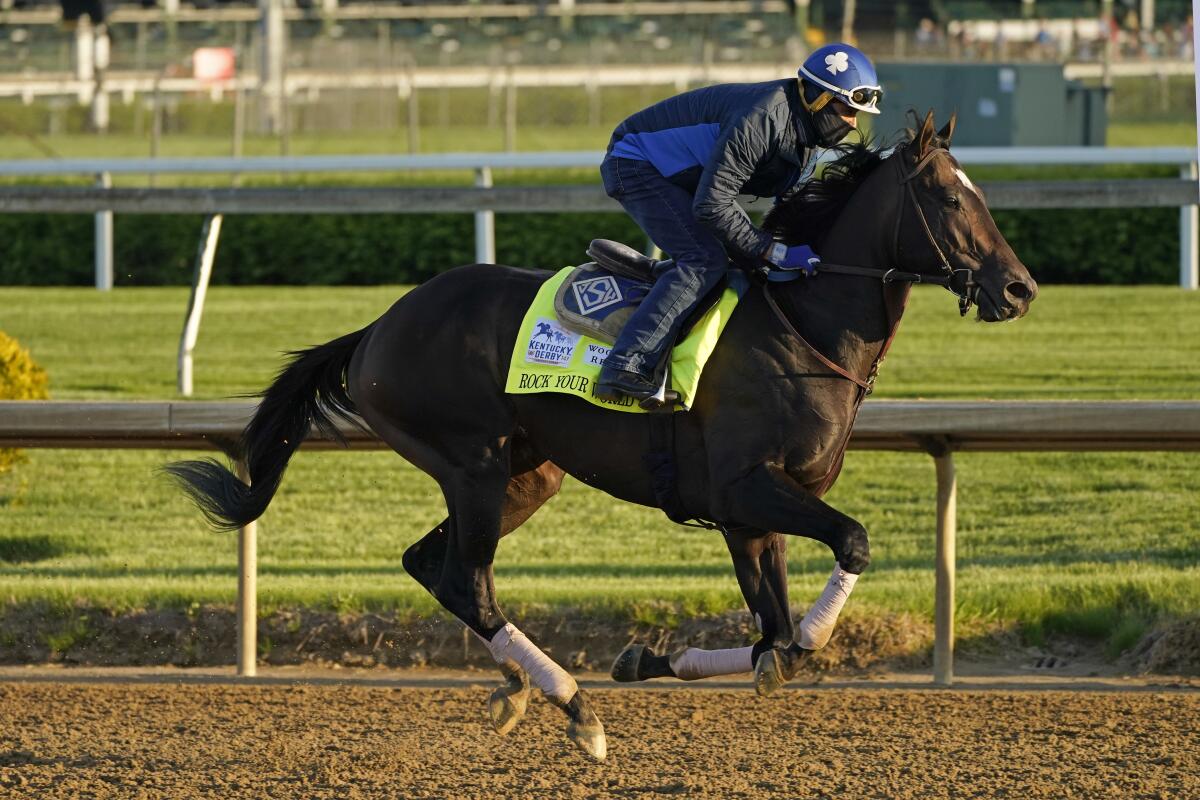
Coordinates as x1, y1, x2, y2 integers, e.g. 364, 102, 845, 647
613, 529, 793, 681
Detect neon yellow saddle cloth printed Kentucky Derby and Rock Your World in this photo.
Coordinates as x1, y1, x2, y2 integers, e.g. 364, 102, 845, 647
504, 266, 745, 414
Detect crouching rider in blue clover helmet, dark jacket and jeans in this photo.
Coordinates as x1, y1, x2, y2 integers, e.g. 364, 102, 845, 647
595, 43, 882, 399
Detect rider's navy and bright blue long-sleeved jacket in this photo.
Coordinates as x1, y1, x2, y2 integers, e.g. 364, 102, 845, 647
608, 78, 816, 263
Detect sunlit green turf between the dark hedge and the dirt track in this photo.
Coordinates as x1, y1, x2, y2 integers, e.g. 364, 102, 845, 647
0, 287, 1200, 649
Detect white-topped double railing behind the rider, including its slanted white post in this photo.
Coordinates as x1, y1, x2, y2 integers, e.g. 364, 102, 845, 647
0, 148, 1200, 397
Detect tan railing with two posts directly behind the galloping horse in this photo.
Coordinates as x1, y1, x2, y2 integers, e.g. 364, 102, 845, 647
0, 401, 1200, 686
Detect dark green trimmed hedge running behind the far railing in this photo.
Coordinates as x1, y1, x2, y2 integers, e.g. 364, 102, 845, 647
0, 209, 1180, 285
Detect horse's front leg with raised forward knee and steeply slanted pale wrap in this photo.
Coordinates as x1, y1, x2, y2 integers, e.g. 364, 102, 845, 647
721, 463, 871, 694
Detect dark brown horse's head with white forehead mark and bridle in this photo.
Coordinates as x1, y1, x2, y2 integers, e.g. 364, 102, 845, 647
888, 112, 1038, 323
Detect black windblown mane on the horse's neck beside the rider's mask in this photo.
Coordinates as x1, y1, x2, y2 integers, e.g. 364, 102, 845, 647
762, 139, 886, 252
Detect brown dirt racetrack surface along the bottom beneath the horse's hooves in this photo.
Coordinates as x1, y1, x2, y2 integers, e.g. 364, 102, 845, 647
0, 669, 1200, 800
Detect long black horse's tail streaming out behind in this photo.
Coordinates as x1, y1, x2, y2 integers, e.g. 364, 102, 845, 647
163, 326, 371, 530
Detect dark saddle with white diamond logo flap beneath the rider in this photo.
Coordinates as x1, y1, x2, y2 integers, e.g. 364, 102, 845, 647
554, 239, 727, 344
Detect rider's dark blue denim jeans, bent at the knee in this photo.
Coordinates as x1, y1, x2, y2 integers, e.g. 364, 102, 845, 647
600, 155, 728, 379
